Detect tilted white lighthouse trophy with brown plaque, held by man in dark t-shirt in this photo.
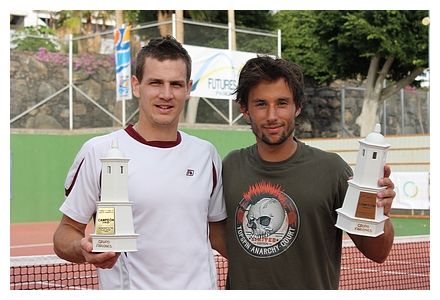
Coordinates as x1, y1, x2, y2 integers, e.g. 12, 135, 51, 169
336, 124, 390, 237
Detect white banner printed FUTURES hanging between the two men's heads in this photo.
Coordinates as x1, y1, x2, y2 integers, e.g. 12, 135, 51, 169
184, 45, 257, 99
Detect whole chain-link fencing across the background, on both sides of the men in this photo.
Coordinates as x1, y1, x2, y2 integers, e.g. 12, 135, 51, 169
10, 19, 430, 137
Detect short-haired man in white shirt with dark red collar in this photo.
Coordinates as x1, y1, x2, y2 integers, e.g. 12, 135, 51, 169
54, 37, 226, 289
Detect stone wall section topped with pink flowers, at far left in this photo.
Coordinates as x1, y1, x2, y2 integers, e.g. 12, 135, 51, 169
10, 50, 137, 129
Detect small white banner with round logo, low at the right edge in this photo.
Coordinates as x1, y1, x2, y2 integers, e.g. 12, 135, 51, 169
390, 172, 429, 209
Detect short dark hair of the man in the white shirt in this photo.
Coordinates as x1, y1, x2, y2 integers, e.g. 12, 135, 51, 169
136, 36, 191, 82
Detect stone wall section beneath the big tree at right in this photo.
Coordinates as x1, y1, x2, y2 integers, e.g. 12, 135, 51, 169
295, 80, 430, 138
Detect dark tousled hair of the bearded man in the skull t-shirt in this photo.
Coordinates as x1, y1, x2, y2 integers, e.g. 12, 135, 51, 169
234, 56, 304, 109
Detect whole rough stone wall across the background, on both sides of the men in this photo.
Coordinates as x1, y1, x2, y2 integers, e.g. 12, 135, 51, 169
10, 49, 429, 138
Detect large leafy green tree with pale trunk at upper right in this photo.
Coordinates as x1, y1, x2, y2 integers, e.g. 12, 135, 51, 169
275, 10, 429, 136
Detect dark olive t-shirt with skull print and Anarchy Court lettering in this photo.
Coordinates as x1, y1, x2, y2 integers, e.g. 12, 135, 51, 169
223, 141, 352, 289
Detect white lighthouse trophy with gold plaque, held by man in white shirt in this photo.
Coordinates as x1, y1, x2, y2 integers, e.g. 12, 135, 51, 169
91, 140, 138, 252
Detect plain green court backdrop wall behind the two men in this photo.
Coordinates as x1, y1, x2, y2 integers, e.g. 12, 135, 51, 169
10, 129, 430, 236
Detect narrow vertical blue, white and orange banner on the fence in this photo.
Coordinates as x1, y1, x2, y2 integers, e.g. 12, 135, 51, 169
114, 26, 132, 101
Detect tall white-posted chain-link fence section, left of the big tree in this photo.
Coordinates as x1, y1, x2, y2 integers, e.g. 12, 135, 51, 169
10, 18, 280, 129
